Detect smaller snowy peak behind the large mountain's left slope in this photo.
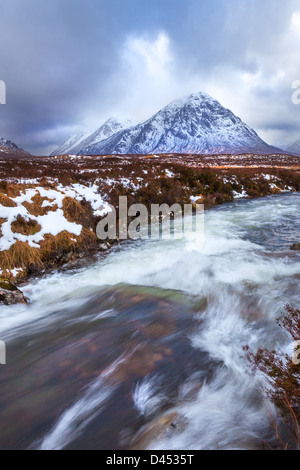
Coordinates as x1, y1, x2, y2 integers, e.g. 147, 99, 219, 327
50, 117, 131, 156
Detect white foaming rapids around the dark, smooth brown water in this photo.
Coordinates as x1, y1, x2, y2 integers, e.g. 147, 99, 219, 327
0, 194, 300, 449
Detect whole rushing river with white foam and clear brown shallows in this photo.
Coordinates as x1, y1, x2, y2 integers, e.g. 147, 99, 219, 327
0, 194, 300, 450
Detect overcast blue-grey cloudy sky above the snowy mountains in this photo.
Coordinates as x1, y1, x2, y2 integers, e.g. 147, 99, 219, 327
0, 0, 300, 154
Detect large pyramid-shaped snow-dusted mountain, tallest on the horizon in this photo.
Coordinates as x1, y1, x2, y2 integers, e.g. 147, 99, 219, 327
78, 93, 282, 155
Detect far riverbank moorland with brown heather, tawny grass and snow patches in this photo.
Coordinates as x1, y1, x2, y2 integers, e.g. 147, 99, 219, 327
0, 155, 300, 283
